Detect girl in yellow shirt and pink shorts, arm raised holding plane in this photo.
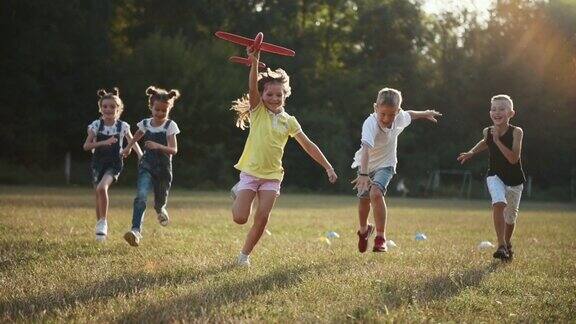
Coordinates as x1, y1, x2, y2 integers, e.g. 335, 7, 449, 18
232, 51, 338, 266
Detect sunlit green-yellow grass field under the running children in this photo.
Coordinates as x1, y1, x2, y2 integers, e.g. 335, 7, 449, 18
0, 187, 576, 322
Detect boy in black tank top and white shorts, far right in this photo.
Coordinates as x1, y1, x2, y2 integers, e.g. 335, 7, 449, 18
458, 95, 526, 260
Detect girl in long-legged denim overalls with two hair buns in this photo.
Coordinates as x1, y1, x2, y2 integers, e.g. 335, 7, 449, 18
122, 87, 180, 246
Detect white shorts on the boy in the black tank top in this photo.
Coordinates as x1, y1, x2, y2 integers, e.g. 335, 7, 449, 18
486, 175, 524, 224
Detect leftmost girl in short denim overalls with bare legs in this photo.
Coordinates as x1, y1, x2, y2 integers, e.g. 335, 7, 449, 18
84, 88, 142, 241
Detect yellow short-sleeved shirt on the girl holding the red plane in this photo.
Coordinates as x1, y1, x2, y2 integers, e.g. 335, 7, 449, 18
234, 102, 302, 181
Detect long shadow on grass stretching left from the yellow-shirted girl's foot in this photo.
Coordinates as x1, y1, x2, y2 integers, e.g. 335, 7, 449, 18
0, 264, 237, 320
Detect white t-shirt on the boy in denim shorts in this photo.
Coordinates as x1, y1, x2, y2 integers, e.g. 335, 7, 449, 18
352, 109, 412, 172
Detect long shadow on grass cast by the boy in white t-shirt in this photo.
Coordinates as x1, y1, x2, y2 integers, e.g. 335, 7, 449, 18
113, 260, 342, 323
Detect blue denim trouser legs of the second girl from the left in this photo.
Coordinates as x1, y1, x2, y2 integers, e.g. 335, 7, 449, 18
132, 168, 172, 232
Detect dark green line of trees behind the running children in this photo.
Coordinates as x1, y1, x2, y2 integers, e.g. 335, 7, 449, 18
0, 0, 576, 199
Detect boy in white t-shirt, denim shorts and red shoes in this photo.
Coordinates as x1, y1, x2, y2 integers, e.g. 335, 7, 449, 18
352, 88, 442, 253
